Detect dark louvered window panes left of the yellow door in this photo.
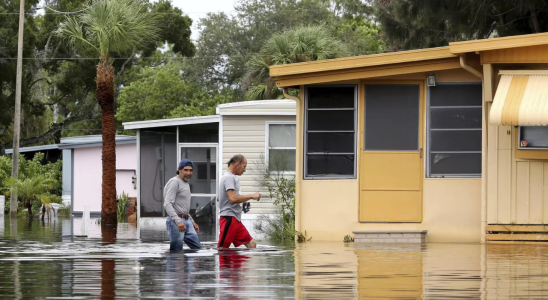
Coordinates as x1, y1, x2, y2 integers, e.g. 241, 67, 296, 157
305, 85, 357, 178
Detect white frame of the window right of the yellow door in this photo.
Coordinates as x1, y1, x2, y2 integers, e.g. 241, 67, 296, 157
424, 81, 484, 178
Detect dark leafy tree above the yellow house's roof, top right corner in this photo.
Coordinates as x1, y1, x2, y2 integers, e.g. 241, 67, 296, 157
370, 0, 548, 50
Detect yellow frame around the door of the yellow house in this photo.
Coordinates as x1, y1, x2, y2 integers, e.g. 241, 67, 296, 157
356, 79, 426, 223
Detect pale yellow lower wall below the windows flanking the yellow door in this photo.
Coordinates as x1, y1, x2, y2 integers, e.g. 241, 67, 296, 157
300, 178, 481, 242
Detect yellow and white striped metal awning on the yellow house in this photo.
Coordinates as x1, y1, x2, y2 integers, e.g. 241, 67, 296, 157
489, 70, 548, 126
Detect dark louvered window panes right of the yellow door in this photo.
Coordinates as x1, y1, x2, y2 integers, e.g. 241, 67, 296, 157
427, 83, 482, 177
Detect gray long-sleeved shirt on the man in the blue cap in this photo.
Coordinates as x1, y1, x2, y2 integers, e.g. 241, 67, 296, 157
164, 176, 192, 223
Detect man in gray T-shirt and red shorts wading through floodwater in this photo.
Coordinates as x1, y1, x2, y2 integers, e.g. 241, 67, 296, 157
217, 154, 261, 248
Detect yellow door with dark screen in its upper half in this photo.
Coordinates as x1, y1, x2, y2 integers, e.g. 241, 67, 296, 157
360, 82, 423, 222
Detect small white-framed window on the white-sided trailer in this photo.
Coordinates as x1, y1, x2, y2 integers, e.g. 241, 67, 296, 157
267, 124, 296, 172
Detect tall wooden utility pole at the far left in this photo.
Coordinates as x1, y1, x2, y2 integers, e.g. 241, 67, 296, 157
10, 0, 25, 217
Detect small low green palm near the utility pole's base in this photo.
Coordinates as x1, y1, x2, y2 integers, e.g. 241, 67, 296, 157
7, 176, 56, 219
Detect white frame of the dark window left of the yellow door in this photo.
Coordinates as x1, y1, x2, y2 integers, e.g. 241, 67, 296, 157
299, 84, 359, 180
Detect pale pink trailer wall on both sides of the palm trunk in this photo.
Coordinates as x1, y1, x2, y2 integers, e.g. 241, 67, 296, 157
72, 144, 137, 212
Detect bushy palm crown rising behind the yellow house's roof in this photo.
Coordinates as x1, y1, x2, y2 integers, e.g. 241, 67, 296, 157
245, 26, 347, 100
